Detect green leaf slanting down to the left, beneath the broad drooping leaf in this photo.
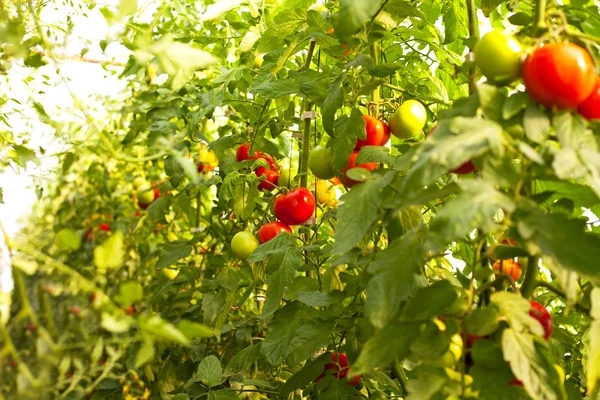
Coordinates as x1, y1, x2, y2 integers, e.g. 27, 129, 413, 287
348, 322, 420, 376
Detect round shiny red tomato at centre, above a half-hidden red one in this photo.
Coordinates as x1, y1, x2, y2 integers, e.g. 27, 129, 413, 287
273, 188, 316, 225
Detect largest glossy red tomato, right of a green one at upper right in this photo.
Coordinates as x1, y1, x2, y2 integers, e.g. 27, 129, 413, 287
523, 42, 596, 109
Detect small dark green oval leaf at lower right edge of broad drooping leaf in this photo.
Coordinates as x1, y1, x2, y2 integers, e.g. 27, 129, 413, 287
400, 280, 458, 322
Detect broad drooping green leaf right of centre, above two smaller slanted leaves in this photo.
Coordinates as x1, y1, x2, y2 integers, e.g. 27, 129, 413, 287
364, 228, 425, 328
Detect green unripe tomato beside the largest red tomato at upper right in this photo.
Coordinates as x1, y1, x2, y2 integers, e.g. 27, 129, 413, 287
474, 30, 523, 85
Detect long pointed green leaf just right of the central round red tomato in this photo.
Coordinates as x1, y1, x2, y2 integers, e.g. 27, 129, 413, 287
333, 170, 393, 254
